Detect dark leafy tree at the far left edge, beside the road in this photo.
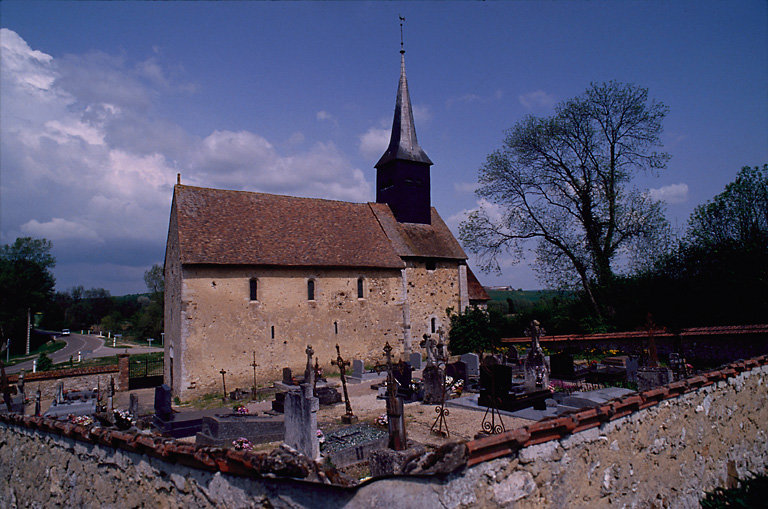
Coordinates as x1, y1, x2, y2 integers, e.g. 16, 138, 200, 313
0, 237, 56, 353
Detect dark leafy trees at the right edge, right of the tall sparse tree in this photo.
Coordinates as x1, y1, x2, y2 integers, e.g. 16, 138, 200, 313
606, 166, 768, 330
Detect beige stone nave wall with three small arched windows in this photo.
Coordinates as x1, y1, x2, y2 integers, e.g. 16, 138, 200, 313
174, 266, 403, 399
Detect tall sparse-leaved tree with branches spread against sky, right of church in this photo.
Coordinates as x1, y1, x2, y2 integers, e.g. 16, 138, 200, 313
460, 82, 669, 316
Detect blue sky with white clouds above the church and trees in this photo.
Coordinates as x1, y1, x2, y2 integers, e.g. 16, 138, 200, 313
0, 0, 768, 295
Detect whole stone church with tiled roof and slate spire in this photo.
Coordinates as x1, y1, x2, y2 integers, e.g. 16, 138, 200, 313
165, 51, 488, 399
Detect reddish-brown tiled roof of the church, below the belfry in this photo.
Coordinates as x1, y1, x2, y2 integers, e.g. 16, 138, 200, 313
172, 185, 466, 268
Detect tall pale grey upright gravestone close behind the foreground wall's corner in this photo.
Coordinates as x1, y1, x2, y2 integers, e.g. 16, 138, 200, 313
284, 383, 320, 460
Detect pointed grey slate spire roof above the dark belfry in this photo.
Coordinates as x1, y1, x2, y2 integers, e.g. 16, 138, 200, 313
376, 50, 432, 168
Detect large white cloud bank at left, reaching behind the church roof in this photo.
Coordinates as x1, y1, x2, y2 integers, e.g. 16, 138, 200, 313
0, 29, 372, 287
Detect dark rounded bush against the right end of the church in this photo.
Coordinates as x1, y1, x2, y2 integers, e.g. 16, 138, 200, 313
448, 306, 505, 355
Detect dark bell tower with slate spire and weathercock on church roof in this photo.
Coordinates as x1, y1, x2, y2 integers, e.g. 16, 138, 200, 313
376, 18, 432, 224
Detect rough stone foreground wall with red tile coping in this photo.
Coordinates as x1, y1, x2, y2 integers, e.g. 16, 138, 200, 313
0, 355, 768, 508
